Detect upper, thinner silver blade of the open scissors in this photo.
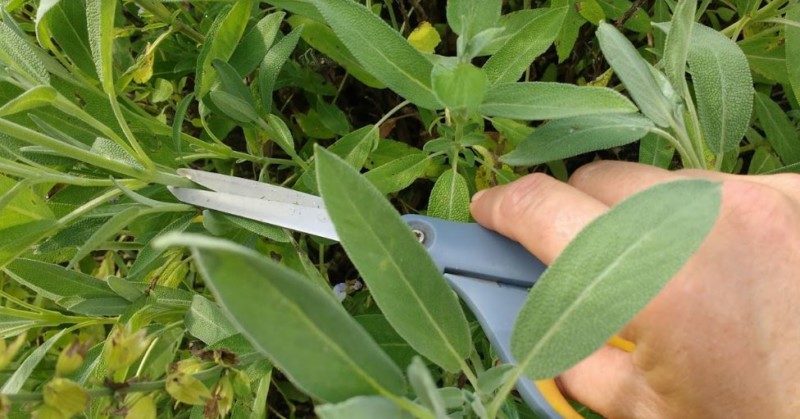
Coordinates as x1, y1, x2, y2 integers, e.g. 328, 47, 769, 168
178, 169, 325, 208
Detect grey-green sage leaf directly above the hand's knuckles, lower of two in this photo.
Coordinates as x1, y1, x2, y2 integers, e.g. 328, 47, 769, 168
500, 114, 653, 166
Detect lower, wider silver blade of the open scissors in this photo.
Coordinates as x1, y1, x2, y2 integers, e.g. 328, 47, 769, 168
169, 187, 339, 241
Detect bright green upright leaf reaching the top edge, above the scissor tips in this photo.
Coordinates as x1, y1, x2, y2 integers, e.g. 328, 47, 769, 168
195, 0, 252, 99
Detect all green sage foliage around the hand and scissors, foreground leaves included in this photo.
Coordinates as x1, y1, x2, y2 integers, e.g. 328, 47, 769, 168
0, 0, 800, 418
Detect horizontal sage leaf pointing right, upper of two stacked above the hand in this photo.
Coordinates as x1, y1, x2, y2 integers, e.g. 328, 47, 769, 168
480, 82, 636, 121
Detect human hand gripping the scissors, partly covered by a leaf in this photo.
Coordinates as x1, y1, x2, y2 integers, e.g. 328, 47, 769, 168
471, 161, 800, 418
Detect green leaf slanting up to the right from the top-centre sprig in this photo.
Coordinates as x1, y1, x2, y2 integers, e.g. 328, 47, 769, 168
483, 7, 567, 84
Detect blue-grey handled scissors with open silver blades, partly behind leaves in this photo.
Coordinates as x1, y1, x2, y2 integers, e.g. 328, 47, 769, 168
170, 169, 581, 418
